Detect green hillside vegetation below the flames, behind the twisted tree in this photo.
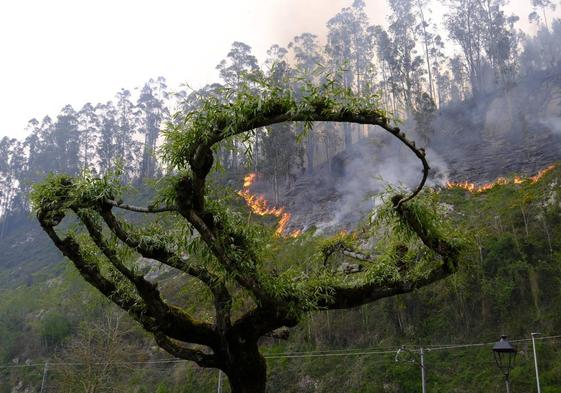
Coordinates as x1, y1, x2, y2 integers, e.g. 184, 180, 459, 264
5, 165, 561, 393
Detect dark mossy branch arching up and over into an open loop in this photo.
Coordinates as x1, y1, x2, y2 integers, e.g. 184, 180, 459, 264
172, 97, 429, 312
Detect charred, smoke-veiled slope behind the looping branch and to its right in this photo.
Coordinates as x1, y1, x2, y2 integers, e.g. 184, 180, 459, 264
254, 72, 561, 232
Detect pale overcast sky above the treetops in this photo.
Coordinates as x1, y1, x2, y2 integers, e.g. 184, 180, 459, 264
0, 0, 552, 138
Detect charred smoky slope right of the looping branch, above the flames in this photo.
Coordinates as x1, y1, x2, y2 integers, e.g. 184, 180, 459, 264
431, 70, 561, 182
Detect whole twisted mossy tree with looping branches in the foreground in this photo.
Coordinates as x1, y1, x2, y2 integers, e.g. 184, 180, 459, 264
32, 82, 460, 393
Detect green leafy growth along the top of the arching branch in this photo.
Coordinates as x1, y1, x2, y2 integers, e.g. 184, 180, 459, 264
160, 74, 388, 169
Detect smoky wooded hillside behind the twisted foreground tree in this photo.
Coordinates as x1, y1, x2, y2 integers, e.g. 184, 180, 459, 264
0, 0, 561, 393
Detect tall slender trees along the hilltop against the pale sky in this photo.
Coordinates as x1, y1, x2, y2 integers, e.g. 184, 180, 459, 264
0, 0, 561, 238
